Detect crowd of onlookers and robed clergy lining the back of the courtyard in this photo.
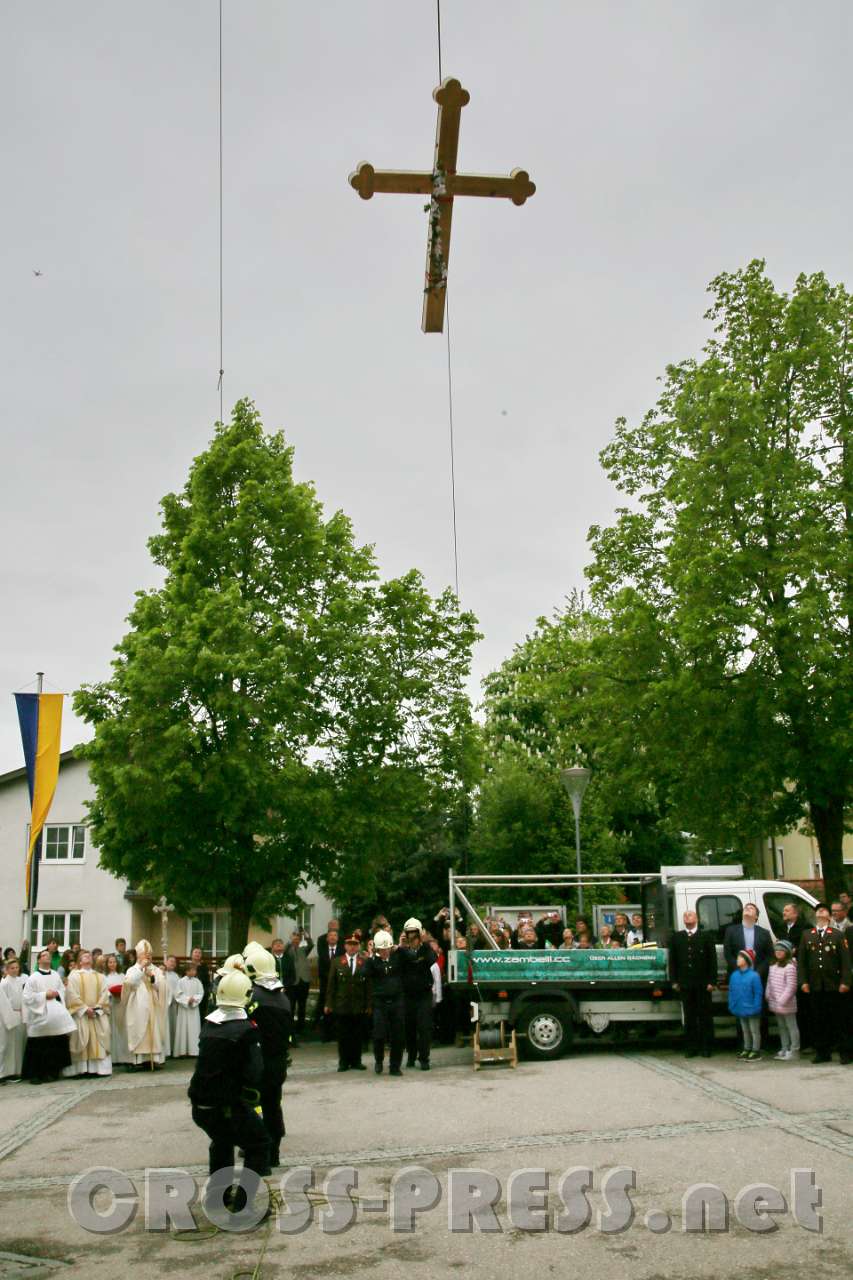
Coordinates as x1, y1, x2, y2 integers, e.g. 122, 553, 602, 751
0, 895, 853, 1084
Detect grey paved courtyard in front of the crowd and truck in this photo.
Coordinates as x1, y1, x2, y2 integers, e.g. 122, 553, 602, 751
0, 1043, 853, 1280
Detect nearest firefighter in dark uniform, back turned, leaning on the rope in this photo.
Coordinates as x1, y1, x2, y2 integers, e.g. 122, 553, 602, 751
187, 970, 270, 1208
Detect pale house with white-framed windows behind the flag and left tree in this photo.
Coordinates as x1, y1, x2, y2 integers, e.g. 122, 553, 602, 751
0, 751, 336, 956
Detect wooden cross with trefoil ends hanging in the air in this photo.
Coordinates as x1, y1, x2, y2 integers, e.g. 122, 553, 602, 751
350, 78, 537, 333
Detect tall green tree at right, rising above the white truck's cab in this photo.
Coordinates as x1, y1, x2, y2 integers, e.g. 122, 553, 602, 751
589, 261, 853, 892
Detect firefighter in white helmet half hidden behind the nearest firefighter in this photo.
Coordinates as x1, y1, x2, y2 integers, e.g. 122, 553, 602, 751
243, 942, 291, 1169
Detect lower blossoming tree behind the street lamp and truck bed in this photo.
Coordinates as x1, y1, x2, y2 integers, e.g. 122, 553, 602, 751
476, 594, 684, 872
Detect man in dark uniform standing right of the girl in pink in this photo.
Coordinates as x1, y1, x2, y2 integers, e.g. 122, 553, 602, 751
798, 902, 853, 1062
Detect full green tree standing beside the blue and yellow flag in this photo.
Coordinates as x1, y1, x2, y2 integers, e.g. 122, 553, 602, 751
74, 401, 476, 945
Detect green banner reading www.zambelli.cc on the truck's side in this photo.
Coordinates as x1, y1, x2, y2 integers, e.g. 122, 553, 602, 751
456, 947, 666, 984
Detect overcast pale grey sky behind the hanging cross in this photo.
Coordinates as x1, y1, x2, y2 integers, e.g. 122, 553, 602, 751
0, 0, 853, 771
